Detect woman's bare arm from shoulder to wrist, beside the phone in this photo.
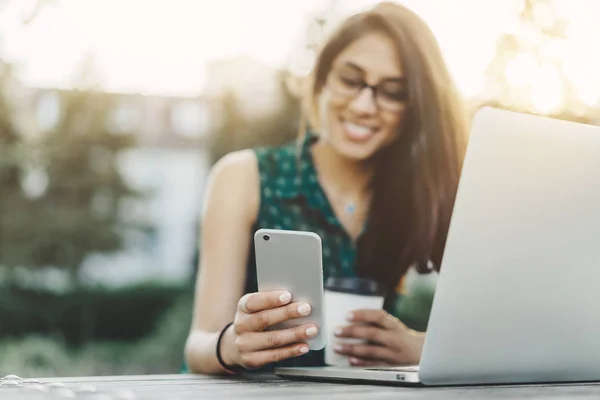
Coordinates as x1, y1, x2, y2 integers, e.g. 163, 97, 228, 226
185, 150, 260, 374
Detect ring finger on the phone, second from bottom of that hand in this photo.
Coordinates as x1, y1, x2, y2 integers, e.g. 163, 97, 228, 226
235, 325, 318, 353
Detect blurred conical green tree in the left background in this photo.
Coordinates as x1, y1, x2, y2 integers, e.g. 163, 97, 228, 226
24, 84, 149, 286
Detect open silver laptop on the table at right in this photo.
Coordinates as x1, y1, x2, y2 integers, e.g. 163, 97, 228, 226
276, 107, 600, 386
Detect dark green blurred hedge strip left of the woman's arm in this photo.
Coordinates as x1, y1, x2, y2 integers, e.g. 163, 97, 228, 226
0, 285, 190, 347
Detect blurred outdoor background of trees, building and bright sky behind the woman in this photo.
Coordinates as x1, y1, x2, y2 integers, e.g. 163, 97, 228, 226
0, 0, 600, 377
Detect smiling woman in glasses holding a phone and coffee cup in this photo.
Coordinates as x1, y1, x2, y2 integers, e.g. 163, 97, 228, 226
186, 3, 466, 374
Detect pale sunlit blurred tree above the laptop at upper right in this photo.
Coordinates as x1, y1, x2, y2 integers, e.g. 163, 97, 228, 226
483, 0, 590, 121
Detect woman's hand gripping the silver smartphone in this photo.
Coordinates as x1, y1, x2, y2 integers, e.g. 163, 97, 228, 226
222, 291, 318, 369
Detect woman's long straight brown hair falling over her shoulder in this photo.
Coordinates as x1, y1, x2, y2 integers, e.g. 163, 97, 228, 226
308, 2, 467, 292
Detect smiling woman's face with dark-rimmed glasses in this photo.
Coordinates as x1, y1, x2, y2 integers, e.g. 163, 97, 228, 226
318, 33, 407, 161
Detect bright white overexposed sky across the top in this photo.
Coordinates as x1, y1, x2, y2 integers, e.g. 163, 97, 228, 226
0, 0, 600, 111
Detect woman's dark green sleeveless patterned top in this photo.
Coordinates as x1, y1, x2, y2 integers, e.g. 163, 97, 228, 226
241, 133, 437, 365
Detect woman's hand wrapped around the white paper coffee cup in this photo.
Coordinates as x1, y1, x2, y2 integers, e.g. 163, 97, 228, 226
334, 310, 425, 366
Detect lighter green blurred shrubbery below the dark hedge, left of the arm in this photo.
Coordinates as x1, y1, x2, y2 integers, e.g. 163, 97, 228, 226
0, 293, 193, 378
